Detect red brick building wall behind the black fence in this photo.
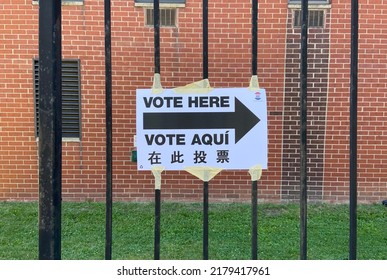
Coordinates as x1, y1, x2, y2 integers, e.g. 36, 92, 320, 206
0, 0, 387, 205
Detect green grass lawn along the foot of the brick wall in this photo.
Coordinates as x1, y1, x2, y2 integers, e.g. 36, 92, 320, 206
0, 202, 387, 260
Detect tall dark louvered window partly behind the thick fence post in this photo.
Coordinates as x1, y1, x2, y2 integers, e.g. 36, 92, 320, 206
34, 59, 81, 138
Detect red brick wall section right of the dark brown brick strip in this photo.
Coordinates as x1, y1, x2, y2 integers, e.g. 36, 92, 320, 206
324, 1, 387, 201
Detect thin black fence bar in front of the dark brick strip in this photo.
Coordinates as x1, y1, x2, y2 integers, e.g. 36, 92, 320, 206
300, 0, 308, 260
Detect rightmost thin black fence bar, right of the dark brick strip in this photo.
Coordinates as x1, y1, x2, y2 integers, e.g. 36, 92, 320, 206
349, 0, 359, 260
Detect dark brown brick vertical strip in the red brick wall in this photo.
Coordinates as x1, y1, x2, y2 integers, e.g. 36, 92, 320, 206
282, 7, 330, 200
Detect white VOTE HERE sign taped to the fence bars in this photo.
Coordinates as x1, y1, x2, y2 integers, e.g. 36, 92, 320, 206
136, 88, 267, 170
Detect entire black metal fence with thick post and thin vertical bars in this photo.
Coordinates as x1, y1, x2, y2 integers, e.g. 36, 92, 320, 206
39, 0, 358, 259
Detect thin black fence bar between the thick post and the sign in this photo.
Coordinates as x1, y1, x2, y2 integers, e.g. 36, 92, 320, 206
104, 0, 113, 260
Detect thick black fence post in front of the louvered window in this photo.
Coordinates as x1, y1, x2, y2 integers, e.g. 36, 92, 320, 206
39, 0, 62, 260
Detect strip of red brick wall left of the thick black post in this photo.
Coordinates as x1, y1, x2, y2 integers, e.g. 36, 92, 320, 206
0, 0, 38, 200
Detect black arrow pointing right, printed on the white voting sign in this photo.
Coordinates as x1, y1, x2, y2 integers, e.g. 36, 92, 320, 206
143, 97, 260, 143
